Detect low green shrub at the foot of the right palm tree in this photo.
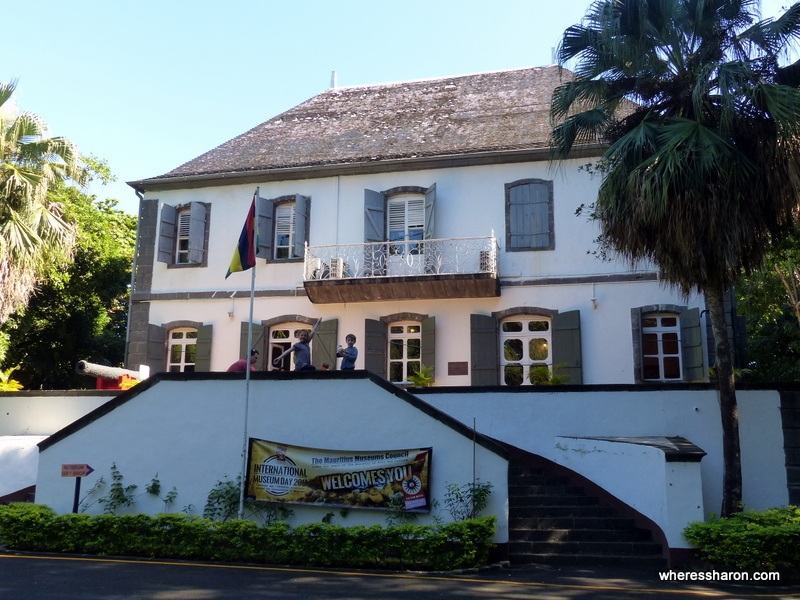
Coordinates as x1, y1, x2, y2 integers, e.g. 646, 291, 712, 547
683, 506, 800, 573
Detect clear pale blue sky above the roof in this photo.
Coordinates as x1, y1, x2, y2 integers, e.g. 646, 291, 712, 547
0, 0, 788, 212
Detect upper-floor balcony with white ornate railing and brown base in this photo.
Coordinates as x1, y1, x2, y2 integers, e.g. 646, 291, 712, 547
303, 235, 500, 303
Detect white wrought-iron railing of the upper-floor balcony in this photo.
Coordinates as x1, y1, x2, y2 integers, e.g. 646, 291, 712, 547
304, 235, 497, 281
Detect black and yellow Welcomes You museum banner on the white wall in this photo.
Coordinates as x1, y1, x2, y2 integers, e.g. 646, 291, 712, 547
247, 438, 432, 512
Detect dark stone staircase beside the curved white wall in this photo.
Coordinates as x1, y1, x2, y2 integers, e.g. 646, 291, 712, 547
508, 458, 667, 569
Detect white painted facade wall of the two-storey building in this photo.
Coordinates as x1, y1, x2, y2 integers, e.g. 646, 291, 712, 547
134, 160, 702, 386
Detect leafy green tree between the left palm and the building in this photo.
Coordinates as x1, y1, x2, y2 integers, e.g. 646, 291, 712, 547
0, 184, 136, 389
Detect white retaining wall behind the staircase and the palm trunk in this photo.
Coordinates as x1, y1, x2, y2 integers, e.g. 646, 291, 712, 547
420, 388, 789, 522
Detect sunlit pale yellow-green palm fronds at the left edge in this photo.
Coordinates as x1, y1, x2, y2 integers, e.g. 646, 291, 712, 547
0, 81, 86, 324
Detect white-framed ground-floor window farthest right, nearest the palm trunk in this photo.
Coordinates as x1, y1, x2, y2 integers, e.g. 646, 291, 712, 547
642, 313, 682, 381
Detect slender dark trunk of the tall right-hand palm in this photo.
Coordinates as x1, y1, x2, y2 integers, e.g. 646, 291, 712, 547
706, 287, 742, 517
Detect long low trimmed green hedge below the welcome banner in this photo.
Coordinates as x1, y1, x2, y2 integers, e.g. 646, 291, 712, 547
0, 503, 495, 571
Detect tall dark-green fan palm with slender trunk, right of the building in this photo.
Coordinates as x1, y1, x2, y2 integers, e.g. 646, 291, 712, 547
551, 0, 800, 515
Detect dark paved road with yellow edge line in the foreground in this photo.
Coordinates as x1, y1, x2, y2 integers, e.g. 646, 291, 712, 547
0, 554, 800, 600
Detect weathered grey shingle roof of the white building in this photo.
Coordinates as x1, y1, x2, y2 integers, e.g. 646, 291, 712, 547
141, 66, 576, 183
